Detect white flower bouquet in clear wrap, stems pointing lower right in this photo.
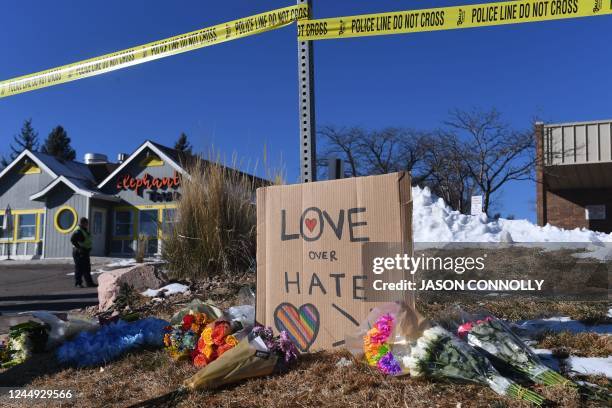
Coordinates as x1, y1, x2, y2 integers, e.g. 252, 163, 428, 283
404, 326, 544, 405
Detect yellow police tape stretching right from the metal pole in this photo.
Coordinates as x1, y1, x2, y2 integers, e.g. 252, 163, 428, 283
298, 0, 612, 40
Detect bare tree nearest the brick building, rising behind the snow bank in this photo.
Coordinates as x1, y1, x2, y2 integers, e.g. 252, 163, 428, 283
446, 109, 535, 217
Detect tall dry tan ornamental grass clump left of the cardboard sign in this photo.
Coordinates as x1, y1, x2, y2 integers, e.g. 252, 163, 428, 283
162, 159, 259, 278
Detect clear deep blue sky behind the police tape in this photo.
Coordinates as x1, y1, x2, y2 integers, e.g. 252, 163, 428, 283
0, 0, 612, 220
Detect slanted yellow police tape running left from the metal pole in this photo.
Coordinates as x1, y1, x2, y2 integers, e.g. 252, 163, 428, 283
0, 4, 309, 98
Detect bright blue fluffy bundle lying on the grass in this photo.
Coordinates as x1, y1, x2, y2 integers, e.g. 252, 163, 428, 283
56, 317, 168, 367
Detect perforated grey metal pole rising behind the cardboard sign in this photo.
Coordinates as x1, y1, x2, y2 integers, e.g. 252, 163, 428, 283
297, 0, 317, 183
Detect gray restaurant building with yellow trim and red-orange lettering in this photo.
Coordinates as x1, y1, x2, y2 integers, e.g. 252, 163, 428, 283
0, 141, 190, 259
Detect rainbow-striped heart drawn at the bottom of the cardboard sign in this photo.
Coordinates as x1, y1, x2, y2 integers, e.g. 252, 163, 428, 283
274, 303, 320, 352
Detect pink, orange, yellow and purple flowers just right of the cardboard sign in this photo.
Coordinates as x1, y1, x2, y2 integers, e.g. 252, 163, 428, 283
363, 313, 403, 375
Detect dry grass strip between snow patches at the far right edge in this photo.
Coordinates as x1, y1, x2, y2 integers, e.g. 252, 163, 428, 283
537, 332, 612, 357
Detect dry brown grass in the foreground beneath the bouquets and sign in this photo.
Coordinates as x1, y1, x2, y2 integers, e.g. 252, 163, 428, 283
0, 351, 601, 408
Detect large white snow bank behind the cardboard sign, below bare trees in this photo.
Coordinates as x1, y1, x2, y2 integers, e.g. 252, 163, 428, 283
412, 187, 612, 243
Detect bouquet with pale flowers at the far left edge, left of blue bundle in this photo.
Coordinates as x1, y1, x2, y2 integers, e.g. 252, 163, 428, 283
0, 321, 49, 368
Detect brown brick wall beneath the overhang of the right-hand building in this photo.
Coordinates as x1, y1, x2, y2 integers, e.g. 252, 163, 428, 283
538, 189, 612, 233
